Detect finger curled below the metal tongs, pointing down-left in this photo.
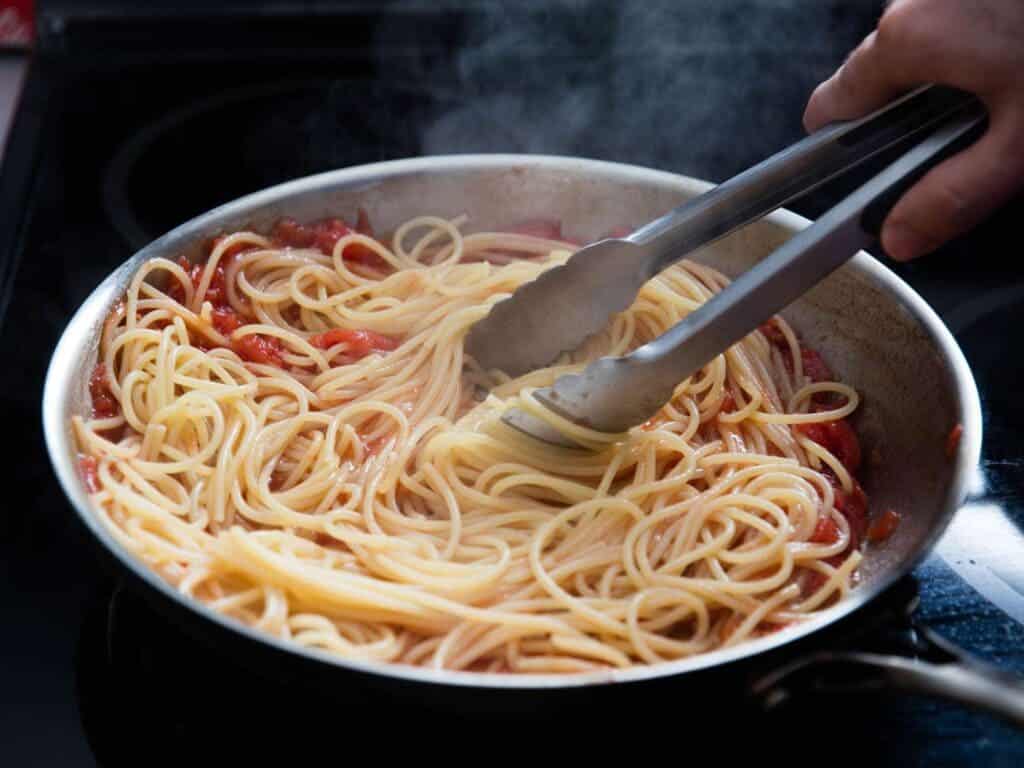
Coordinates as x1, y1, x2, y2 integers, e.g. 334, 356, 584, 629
882, 115, 1024, 261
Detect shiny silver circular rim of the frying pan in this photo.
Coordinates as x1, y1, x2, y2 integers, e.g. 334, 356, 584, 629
42, 155, 982, 690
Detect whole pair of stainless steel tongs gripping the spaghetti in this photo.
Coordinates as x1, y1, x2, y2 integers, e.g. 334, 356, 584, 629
466, 85, 987, 446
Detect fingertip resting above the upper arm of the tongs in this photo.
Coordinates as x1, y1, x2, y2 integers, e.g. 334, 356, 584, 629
804, 32, 925, 132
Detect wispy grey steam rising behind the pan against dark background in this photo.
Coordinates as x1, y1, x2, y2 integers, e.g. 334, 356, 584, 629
382, 0, 882, 186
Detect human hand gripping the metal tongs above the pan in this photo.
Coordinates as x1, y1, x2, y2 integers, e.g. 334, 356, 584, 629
804, 0, 1024, 260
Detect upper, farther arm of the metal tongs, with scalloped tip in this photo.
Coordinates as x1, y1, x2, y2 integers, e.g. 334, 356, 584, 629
466, 86, 981, 376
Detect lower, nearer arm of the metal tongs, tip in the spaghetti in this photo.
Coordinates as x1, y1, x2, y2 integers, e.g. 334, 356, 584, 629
516, 103, 986, 443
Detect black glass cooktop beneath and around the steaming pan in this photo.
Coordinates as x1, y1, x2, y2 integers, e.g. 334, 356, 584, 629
0, 0, 1024, 766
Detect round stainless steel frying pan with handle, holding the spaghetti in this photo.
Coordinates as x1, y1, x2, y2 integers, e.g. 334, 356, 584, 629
43, 155, 1024, 724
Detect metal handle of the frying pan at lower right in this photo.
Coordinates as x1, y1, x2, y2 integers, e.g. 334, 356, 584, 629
753, 624, 1024, 728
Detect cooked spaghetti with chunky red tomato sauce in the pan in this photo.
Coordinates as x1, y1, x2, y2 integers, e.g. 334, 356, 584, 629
74, 214, 866, 673
